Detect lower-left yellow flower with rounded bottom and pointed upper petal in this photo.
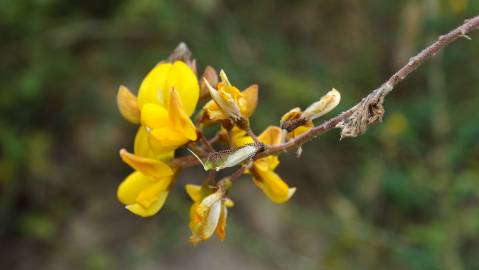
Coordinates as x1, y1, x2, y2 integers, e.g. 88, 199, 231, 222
117, 149, 174, 217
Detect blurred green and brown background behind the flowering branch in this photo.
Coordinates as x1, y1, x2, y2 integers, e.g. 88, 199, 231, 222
0, 0, 479, 270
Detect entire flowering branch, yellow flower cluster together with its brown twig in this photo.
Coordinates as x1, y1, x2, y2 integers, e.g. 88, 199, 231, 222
113, 16, 479, 244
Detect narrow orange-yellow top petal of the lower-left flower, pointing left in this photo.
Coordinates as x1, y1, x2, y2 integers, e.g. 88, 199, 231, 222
120, 149, 173, 179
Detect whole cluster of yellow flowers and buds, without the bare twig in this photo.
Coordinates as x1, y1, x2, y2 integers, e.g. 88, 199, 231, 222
117, 46, 339, 244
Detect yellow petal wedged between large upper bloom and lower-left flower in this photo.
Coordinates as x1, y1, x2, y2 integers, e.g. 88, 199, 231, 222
134, 127, 174, 161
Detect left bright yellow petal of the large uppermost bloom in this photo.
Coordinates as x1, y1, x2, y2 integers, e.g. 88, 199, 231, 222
138, 63, 173, 110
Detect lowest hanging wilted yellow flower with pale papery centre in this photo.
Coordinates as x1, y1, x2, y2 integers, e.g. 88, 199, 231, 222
186, 185, 233, 245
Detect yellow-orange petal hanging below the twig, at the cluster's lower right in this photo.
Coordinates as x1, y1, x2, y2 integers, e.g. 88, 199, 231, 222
251, 168, 296, 203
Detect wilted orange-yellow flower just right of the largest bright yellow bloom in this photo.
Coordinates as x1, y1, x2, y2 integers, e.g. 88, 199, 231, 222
204, 70, 258, 121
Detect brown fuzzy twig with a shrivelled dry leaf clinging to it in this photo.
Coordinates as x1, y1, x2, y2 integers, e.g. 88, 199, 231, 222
171, 15, 479, 167
